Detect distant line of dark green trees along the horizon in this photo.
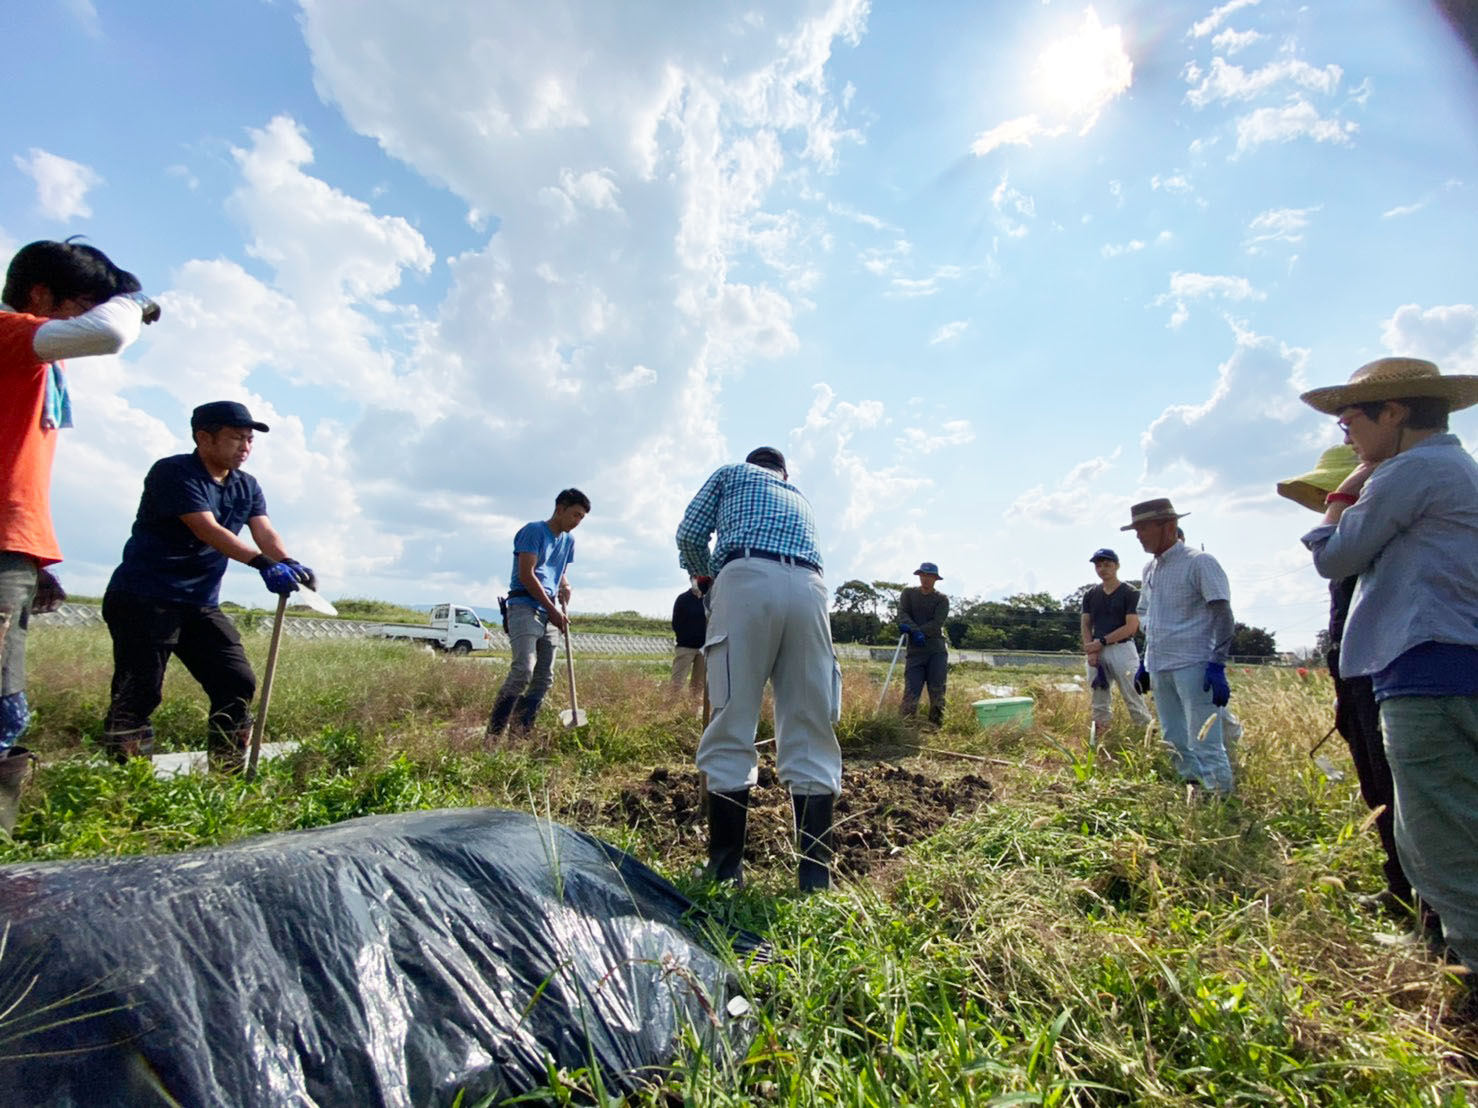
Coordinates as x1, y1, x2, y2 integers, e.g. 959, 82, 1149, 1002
831, 581, 1277, 657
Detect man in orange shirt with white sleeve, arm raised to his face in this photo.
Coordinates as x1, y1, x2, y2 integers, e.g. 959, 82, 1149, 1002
0, 241, 160, 783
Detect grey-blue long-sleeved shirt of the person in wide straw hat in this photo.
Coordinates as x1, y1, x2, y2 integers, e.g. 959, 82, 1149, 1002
1304, 434, 1478, 677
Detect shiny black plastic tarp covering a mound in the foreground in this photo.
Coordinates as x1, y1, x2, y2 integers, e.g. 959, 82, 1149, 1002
0, 808, 754, 1108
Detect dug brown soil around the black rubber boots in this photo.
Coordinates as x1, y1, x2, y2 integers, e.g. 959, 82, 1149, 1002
602, 762, 992, 876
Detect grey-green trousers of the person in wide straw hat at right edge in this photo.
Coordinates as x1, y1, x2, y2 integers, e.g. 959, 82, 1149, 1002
1380, 696, 1478, 974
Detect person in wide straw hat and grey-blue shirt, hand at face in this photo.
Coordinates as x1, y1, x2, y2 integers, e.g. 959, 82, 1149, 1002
1302, 358, 1478, 986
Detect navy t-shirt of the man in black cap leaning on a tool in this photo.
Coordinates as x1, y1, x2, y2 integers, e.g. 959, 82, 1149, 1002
108, 454, 268, 607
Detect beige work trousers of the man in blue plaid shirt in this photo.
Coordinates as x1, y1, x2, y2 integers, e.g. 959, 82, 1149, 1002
698, 558, 841, 796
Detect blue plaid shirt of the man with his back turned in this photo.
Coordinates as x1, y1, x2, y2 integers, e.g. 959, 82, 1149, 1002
677, 462, 822, 578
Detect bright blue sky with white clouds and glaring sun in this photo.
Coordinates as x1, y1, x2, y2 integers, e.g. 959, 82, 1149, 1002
0, 0, 1478, 649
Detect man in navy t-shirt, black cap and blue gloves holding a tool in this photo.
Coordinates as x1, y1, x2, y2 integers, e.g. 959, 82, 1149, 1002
102, 400, 318, 773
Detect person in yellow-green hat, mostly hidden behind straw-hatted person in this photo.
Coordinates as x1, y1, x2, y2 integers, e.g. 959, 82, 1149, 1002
1277, 445, 1441, 935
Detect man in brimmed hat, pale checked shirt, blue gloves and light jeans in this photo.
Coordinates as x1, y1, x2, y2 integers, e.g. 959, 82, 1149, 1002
1119, 498, 1236, 796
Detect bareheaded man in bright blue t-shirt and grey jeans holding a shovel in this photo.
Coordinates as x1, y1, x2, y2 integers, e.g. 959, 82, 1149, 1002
485, 489, 590, 743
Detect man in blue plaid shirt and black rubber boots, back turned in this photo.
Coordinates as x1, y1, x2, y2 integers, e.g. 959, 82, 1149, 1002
677, 446, 841, 892
